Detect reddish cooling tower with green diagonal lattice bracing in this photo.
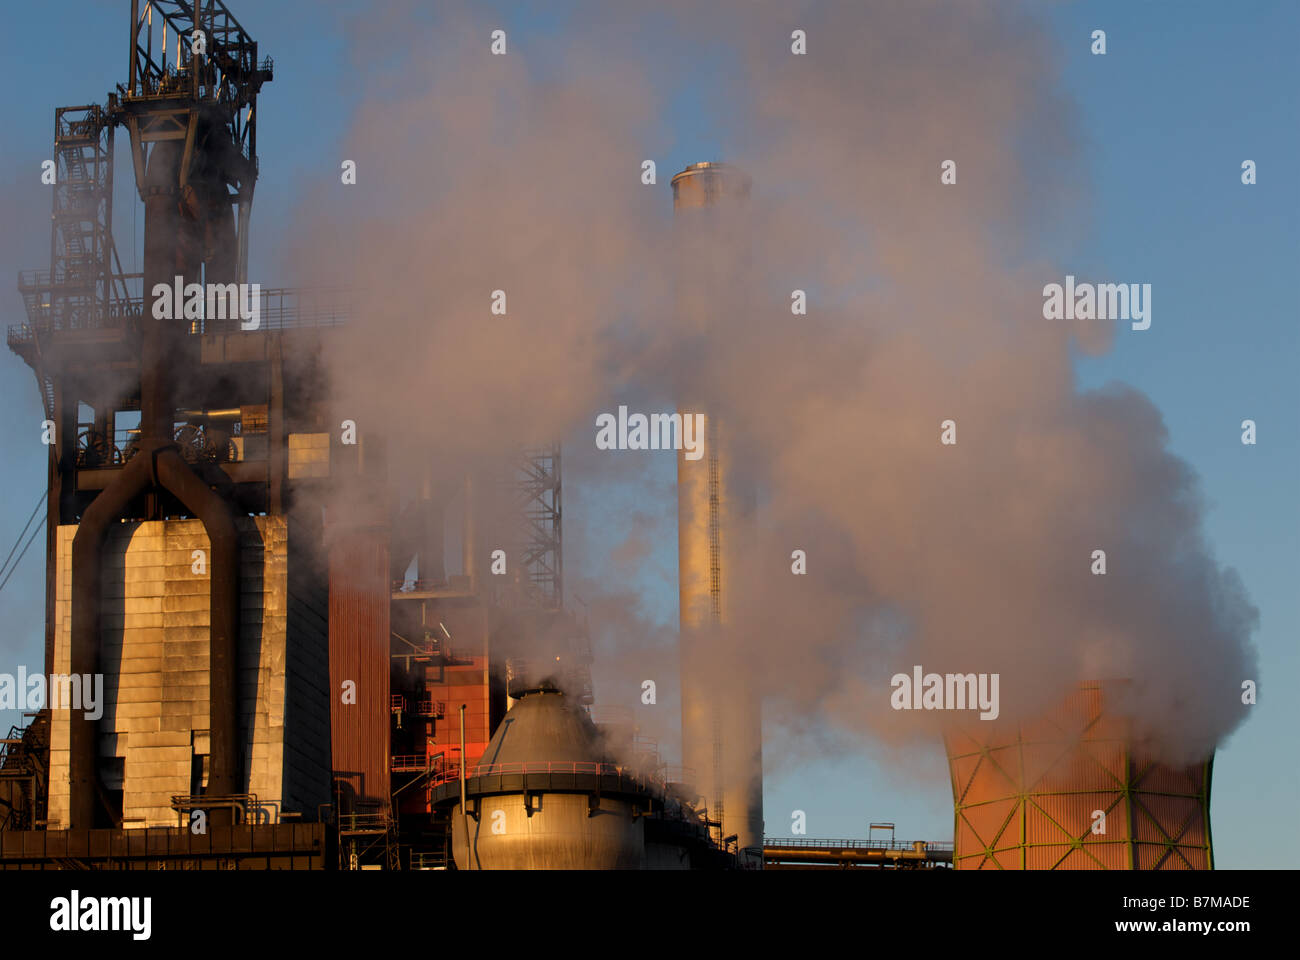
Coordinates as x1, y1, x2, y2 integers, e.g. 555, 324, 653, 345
945, 687, 1213, 870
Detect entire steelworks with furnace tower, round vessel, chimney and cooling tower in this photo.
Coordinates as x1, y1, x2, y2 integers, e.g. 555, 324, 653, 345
0, 0, 1212, 870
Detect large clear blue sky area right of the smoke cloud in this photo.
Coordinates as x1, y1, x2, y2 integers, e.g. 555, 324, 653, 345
1053, 3, 1300, 868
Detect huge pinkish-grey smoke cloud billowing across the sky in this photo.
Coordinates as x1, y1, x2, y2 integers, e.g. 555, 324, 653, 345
289, 3, 1257, 758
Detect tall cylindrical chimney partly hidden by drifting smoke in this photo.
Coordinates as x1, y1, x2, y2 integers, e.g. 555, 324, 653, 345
672, 163, 763, 866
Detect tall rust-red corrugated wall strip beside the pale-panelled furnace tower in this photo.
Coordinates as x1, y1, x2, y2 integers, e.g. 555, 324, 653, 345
328, 524, 391, 812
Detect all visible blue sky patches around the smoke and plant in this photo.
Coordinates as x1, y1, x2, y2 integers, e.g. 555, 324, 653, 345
0, 0, 1300, 868
